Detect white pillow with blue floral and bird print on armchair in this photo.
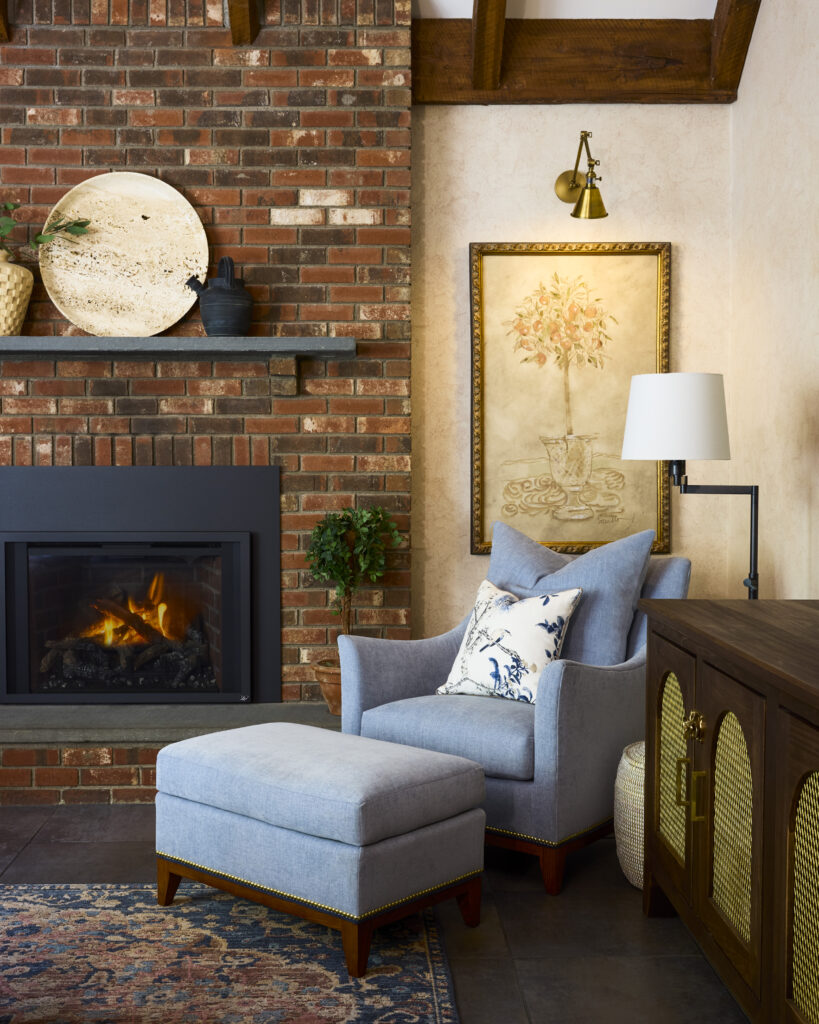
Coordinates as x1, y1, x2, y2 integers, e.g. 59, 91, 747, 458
436, 580, 583, 703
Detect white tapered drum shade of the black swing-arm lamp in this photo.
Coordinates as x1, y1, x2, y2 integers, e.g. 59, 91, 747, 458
620, 374, 731, 462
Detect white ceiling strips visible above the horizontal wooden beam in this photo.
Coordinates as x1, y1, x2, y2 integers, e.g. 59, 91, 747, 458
413, 0, 717, 18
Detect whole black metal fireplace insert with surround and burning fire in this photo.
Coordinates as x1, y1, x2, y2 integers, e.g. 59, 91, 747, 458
0, 466, 282, 703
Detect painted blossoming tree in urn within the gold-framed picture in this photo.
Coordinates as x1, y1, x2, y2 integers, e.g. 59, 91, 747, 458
505, 272, 617, 520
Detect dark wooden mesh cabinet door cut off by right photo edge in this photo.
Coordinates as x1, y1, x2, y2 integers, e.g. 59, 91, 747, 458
773, 711, 819, 1024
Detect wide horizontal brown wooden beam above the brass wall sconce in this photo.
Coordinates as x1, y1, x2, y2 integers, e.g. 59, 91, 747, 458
413, 18, 733, 103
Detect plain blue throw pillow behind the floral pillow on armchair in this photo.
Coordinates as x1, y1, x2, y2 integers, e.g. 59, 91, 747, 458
486, 522, 654, 665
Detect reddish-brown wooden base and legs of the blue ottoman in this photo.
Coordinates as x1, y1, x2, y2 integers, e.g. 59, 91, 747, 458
157, 856, 481, 978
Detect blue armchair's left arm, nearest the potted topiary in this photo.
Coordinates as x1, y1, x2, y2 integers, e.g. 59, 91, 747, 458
339, 617, 468, 733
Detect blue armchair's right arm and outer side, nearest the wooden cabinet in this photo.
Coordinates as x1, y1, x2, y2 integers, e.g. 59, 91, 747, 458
534, 647, 646, 842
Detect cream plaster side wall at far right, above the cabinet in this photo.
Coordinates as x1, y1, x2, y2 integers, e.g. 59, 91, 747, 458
729, 0, 819, 598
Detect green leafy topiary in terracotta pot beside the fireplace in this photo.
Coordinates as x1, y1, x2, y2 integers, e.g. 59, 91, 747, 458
307, 506, 401, 715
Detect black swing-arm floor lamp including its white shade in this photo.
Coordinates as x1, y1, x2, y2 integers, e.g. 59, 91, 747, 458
621, 374, 760, 599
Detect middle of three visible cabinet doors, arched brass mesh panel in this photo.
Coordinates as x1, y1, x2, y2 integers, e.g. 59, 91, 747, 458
691, 664, 765, 996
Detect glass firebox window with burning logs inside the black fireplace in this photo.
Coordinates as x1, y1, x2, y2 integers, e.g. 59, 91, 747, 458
28, 545, 235, 693
